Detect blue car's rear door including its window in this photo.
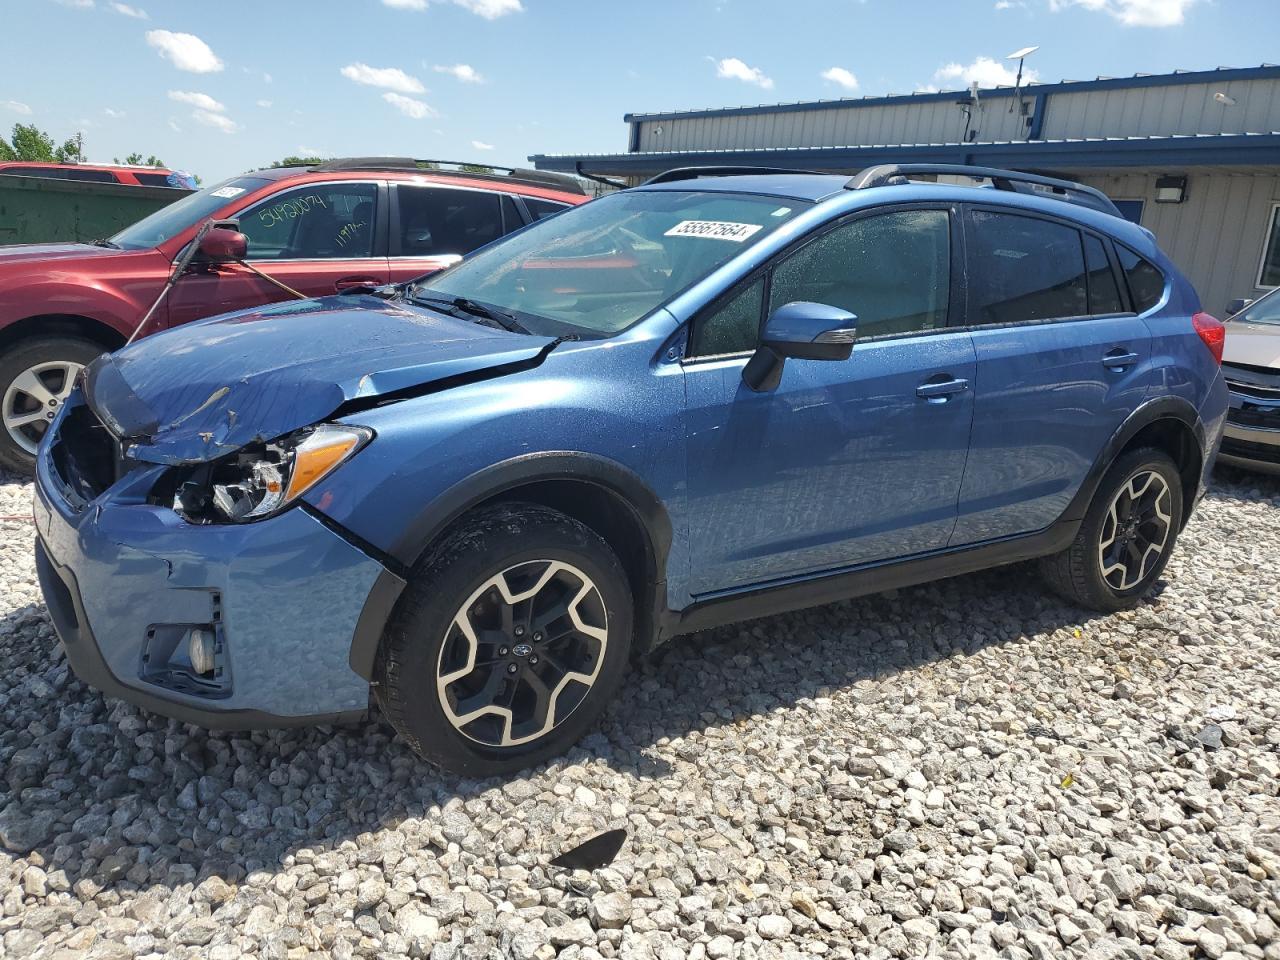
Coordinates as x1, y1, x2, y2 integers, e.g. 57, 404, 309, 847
951, 211, 1153, 545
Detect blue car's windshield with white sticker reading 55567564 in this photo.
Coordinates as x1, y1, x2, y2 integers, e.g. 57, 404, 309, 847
408, 191, 809, 337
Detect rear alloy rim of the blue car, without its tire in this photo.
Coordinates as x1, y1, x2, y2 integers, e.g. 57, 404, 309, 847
1098, 470, 1172, 590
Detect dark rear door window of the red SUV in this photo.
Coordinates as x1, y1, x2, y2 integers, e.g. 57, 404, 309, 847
392, 183, 503, 257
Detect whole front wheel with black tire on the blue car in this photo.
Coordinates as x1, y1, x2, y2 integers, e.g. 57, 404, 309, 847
374, 503, 634, 777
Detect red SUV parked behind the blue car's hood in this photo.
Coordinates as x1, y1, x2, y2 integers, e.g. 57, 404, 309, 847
0, 157, 588, 472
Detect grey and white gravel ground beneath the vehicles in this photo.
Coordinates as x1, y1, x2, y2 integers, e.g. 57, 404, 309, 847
0, 474, 1280, 960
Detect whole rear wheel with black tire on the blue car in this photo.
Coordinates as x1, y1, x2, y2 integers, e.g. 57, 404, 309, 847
1041, 448, 1183, 613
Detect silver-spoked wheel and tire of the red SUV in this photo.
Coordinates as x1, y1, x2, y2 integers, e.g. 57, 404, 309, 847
0, 337, 102, 474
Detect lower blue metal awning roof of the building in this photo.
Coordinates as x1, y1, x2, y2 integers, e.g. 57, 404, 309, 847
529, 132, 1280, 177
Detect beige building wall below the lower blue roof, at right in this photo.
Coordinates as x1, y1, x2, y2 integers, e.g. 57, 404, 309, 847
1079, 173, 1280, 309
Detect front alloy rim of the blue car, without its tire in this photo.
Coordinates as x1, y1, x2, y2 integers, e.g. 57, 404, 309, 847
436, 561, 608, 746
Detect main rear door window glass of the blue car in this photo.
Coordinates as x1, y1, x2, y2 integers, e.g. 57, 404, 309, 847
968, 210, 1089, 325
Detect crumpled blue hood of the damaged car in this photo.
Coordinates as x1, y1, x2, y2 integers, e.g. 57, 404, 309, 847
84, 296, 556, 463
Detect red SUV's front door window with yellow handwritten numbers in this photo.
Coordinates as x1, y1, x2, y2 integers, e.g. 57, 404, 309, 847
238, 183, 378, 260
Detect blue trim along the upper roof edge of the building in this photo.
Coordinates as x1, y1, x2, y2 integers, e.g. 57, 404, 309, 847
622, 64, 1280, 123
